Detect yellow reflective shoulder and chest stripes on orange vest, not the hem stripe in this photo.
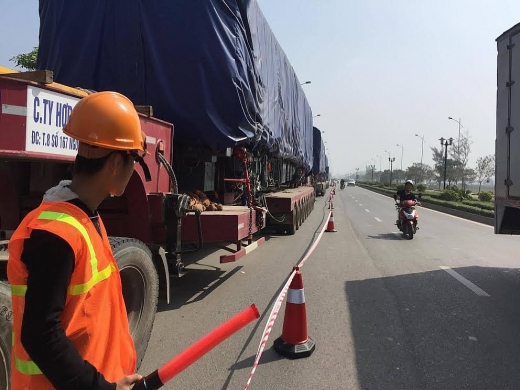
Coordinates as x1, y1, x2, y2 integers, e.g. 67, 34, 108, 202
11, 211, 115, 296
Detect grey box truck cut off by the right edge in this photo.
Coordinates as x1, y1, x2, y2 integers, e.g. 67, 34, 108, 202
494, 23, 520, 235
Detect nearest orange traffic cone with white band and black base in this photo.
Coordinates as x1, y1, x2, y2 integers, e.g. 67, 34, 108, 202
273, 267, 316, 359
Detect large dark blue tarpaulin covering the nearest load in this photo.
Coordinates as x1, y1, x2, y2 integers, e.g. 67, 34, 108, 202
38, 0, 313, 170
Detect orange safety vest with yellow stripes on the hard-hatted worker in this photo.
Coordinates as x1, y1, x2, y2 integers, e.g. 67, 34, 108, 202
7, 202, 136, 390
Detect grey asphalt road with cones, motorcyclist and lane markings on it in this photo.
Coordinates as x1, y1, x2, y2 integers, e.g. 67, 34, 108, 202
139, 187, 520, 390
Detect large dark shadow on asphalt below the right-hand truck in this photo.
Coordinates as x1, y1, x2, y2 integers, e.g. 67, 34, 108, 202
345, 267, 520, 390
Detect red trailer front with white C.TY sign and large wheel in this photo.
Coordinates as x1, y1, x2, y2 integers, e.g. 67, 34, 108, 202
0, 68, 190, 389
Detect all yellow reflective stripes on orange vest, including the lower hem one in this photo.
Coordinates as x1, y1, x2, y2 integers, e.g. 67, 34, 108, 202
11, 211, 116, 375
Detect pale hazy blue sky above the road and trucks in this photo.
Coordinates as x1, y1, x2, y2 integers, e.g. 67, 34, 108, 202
0, 0, 520, 174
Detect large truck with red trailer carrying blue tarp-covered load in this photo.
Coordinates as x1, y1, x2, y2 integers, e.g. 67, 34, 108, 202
0, 0, 328, 389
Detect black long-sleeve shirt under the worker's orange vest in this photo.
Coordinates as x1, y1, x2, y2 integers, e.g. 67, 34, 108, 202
21, 199, 116, 390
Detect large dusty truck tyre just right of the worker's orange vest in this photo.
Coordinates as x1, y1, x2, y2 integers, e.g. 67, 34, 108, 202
110, 237, 159, 368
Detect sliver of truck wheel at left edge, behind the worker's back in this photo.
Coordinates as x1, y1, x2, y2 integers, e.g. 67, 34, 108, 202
0, 281, 13, 389
